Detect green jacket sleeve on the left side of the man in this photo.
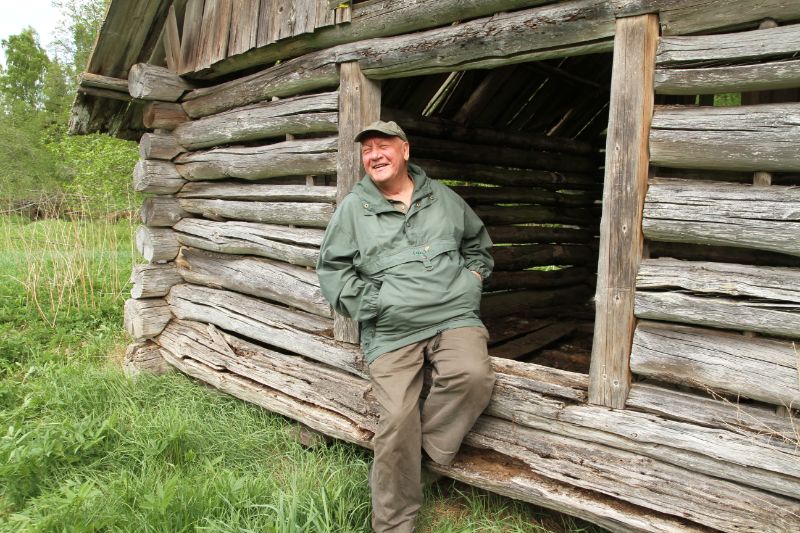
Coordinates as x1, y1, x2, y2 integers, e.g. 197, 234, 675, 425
317, 215, 378, 322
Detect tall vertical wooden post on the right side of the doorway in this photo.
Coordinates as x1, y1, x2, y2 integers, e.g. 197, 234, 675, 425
589, 14, 658, 408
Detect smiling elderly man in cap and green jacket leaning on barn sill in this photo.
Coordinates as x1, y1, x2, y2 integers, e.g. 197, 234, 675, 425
317, 121, 494, 533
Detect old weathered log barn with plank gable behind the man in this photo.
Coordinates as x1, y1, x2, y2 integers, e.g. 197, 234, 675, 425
70, 0, 800, 532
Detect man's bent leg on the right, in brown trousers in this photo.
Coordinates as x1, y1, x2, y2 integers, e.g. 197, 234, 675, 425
422, 327, 494, 465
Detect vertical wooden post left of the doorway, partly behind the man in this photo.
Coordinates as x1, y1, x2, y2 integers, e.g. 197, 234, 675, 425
333, 62, 381, 343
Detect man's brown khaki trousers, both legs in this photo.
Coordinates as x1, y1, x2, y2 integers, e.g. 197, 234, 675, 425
369, 327, 494, 533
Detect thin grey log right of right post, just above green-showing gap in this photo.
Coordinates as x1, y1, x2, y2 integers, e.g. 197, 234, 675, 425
655, 61, 800, 95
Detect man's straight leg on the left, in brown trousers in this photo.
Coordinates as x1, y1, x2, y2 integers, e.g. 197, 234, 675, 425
369, 342, 426, 533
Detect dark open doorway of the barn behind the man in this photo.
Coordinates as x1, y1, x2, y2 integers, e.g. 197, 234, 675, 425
381, 53, 612, 374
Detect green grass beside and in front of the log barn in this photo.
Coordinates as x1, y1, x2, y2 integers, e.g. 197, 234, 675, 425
0, 216, 596, 533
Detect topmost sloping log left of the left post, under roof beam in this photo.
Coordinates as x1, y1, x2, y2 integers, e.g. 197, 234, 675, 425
183, 51, 339, 118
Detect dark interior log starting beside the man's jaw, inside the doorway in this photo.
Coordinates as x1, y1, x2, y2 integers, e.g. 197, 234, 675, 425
412, 157, 602, 190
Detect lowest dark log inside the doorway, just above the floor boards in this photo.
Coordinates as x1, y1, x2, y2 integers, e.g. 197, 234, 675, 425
481, 285, 591, 317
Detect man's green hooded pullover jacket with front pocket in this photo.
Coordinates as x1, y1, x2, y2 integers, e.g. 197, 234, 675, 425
317, 164, 494, 362
